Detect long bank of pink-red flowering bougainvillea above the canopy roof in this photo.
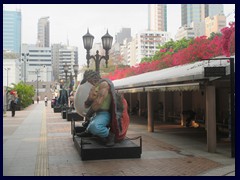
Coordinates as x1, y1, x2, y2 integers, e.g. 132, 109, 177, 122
105, 22, 235, 80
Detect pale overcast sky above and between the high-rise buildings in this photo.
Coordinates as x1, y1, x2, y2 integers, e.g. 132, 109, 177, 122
3, 4, 235, 64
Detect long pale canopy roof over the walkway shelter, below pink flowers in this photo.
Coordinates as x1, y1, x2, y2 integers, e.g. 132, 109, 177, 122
113, 57, 235, 92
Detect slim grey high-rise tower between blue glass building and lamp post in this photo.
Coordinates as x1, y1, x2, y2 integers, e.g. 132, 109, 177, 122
37, 17, 50, 47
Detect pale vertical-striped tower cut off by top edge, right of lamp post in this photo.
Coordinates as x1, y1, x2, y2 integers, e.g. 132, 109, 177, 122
148, 4, 167, 31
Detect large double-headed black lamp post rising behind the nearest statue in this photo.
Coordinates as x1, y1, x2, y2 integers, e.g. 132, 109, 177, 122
83, 30, 113, 72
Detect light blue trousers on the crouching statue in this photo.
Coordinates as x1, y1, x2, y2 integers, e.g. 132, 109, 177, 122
86, 111, 110, 138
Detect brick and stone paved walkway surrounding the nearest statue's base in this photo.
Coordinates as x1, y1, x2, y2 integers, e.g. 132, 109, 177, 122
3, 102, 235, 176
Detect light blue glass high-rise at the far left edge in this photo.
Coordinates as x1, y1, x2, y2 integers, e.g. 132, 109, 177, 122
3, 10, 22, 54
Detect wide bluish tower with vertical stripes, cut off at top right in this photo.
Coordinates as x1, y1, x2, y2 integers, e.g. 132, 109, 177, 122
181, 4, 223, 26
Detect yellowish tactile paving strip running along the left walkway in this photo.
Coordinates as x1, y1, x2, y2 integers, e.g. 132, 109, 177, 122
34, 107, 49, 176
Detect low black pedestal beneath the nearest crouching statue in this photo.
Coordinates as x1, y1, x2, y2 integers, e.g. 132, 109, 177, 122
74, 136, 142, 160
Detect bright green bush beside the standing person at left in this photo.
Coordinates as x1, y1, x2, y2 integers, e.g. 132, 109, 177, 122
8, 81, 35, 108
